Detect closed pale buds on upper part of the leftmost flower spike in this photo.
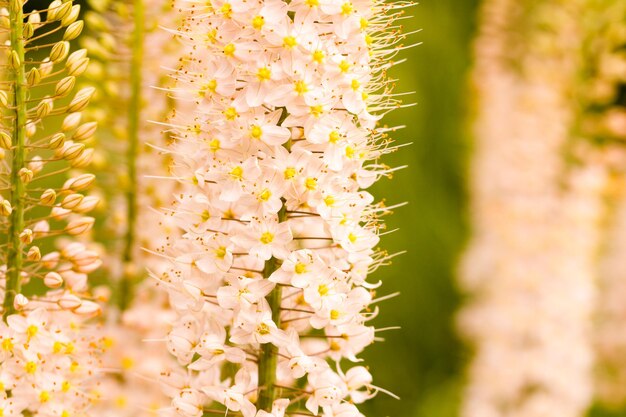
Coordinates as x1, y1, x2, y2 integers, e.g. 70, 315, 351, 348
0, 0, 100, 315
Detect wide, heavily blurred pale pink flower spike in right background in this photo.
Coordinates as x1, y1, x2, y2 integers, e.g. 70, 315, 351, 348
460, 0, 623, 417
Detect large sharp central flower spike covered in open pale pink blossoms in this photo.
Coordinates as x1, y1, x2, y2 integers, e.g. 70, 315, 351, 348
155, 0, 409, 417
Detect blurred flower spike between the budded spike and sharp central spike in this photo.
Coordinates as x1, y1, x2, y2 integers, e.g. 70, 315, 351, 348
81, 0, 179, 417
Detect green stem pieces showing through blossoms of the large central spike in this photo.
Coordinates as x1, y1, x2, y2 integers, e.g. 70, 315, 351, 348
257, 202, 287, 411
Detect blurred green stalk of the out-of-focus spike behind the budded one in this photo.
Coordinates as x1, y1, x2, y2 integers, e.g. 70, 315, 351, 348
118, 0, 145, 311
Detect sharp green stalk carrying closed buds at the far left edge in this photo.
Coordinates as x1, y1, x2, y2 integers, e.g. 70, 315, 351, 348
3, 1, 28, 320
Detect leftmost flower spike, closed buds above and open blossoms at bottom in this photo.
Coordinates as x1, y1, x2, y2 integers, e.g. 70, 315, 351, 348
0, 0, 100, 417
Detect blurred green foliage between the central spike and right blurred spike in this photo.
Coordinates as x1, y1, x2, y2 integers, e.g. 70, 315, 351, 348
356, 0, 477, 417
